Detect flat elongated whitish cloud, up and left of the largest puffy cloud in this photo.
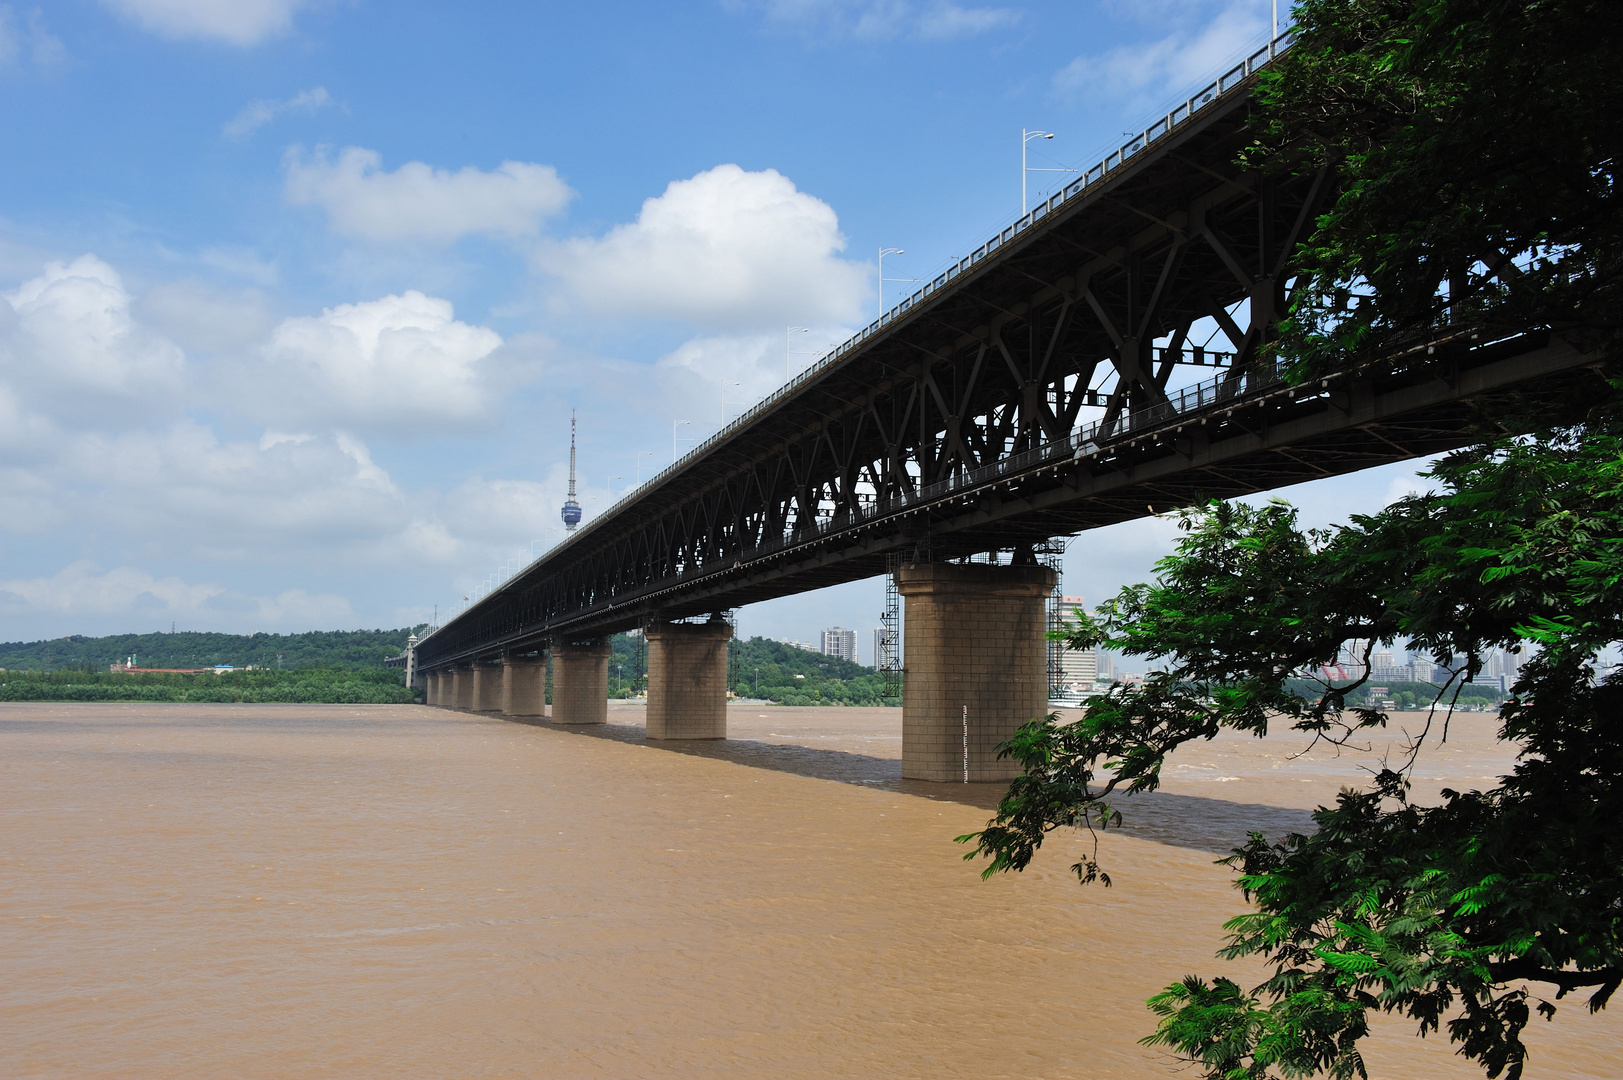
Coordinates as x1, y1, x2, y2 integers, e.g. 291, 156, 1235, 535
284, 146, 573, 244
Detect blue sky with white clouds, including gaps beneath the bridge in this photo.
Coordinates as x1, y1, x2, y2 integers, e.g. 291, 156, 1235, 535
0, 0, 1414, 653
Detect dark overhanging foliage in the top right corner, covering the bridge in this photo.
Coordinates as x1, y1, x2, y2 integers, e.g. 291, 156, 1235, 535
1248, 0, 1623, 375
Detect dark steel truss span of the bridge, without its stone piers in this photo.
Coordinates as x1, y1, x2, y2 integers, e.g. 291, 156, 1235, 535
417, 67, 1594, 669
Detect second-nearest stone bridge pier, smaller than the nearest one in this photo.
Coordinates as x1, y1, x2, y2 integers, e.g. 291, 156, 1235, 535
644, 619, 732, 739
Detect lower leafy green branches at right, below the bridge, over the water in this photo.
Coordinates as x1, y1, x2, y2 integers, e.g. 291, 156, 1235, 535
961, 421, 1623, 1080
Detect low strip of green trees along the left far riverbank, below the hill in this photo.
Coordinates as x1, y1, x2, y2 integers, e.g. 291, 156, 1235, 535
0, 667, 419, 705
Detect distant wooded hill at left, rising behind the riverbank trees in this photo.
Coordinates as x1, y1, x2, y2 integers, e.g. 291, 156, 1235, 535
0, 627, 424, 671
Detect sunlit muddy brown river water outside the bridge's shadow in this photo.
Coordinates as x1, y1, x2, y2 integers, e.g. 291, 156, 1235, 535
0, 705, 1623, 1080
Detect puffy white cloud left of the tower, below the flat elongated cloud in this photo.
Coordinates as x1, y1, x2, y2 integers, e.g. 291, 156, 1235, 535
261, 291, 502, 435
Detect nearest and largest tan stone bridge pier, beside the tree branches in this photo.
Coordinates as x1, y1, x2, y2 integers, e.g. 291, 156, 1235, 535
896, 564, 1055, 783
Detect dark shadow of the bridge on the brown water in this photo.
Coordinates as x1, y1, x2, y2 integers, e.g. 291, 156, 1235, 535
497, 716, 1313, 856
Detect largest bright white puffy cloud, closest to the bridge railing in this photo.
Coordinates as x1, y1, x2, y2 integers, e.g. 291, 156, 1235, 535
539, 164, 870, 326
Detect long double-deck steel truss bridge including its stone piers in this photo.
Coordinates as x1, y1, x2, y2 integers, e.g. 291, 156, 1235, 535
412, 39, 1592, 780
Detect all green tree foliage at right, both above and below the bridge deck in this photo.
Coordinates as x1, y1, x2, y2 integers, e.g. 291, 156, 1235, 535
962, 0, 1623, 1080
